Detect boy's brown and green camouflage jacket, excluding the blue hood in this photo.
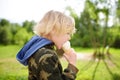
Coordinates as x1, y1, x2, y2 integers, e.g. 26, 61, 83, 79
28, 45, 78, 80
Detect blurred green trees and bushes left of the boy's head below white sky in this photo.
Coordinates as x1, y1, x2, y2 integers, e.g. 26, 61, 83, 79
0, 19, 35, 45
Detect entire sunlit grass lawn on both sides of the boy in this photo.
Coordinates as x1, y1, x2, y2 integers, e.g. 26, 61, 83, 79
0, 45, 120, 80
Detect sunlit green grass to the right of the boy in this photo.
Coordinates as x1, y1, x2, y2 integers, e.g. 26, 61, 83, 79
75, 47, 120, 80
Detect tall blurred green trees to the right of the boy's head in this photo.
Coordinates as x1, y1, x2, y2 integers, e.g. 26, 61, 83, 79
67, 0, 120, 48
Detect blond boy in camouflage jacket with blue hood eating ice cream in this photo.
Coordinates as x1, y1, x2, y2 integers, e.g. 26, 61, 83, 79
16, 10, 78, 80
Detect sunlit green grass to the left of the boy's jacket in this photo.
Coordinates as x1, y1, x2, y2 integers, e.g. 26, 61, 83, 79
0, 45, 28, 80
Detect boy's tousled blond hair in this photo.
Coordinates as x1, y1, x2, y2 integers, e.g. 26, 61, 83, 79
33, 10, 75, 36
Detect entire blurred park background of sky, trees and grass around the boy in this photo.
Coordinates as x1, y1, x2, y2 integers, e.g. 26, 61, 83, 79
0, 0, 120, 80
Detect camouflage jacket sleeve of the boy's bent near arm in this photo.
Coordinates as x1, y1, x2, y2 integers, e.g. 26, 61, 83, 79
39, 52, 78, 80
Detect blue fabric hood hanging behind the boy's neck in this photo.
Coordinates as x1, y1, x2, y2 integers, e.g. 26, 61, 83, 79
16, 36, 53, 66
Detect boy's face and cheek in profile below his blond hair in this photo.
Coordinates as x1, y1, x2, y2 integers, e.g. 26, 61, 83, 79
52, 33, 70, 49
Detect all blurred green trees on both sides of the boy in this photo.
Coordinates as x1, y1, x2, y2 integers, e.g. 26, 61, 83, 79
0, 0, 120, 48
